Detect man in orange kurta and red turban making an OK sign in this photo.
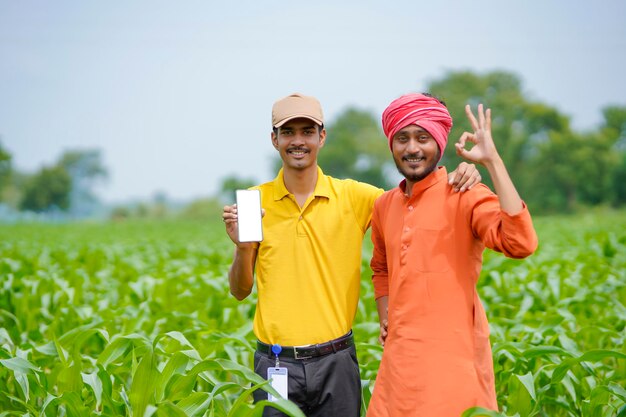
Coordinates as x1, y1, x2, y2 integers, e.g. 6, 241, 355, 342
367, 94, 537, 417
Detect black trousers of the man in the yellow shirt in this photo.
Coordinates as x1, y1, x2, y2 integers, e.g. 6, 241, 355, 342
253, 346, 361, 417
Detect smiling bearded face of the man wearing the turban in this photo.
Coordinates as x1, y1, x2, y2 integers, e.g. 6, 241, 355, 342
391, 125, 440, 188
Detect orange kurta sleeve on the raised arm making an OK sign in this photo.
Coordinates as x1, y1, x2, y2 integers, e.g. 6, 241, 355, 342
470, 187, 538, 259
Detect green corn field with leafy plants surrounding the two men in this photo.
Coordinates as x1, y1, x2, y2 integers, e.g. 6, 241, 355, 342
0, 211, 626, 417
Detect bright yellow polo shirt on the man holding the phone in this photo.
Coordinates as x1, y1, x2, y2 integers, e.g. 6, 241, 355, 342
254, 168, 383, 346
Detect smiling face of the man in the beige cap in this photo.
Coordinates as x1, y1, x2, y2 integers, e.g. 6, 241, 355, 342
272, 118, 326, 170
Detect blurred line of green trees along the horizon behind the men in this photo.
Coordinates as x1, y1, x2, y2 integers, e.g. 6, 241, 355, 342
0, 71, 626, 216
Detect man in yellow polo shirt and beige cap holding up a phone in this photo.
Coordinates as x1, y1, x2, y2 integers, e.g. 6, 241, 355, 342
222, 94, 480, 417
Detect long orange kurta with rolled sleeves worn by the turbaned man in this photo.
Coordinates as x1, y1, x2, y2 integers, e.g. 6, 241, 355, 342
367, 168, 537, 417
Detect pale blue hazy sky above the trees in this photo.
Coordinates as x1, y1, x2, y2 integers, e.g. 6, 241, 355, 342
0, 0, 626, 204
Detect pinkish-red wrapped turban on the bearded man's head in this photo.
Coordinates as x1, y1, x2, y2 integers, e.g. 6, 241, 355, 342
383, 94, 452, 159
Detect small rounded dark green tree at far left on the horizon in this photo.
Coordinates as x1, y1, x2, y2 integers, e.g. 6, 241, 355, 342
19, 166, 72, 213
